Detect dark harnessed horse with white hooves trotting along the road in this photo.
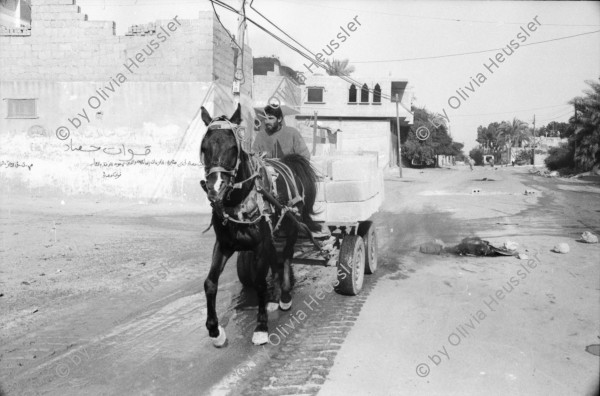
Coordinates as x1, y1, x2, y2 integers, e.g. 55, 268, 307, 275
200, 104, 319, 348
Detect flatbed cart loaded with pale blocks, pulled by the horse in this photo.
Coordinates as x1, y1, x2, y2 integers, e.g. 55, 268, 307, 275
237, 153, 383, 296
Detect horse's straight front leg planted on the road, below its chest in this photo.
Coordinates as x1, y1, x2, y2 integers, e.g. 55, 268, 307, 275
252, 239, 277, 345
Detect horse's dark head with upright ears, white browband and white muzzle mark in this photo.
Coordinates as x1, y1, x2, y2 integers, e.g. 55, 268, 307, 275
200, 104, 242, 202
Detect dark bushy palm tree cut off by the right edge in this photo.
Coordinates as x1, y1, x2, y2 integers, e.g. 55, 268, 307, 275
569, 80, 600, 171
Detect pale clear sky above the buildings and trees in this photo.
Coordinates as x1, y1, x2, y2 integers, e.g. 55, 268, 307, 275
77, 0, 600, 150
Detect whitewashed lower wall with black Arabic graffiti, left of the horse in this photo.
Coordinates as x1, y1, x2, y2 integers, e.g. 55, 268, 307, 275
0, 82, 252, 204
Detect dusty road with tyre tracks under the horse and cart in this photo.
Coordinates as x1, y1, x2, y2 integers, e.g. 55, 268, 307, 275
0, 167, 600, 395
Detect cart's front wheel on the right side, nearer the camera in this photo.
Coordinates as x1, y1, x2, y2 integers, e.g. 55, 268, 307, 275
335, 235, 365, 296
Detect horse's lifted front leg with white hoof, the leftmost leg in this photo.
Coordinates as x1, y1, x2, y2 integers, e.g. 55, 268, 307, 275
204, 241, 233, 348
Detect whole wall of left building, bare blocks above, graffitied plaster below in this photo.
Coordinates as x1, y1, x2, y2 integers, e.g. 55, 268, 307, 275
0, 0, 252, 203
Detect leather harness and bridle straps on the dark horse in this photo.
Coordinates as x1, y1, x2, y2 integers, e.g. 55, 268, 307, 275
200, 117, 304, 234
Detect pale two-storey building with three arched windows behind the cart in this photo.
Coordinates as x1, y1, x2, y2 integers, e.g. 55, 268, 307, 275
296, 75, 413, 167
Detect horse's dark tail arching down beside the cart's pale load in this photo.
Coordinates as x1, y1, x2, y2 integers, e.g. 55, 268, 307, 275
280, 154, 320, 231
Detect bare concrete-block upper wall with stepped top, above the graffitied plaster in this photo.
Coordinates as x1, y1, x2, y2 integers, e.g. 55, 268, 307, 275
0, 0, 252, 89
